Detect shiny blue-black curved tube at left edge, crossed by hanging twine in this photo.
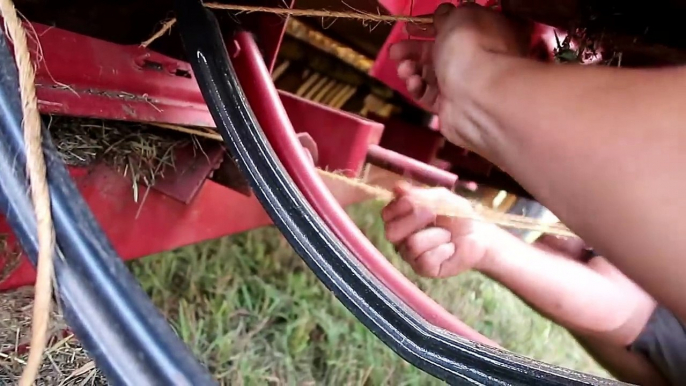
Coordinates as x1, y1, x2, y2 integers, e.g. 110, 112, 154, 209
0, 31, 214, 386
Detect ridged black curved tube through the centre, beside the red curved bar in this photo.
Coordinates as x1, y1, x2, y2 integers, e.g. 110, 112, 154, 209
175, 0, 614, 385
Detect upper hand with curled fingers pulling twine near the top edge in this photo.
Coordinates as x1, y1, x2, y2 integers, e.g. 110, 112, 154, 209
389, 3, 533, 154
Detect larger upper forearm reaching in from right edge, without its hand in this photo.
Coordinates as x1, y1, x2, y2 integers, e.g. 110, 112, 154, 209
477, 59, 686, 320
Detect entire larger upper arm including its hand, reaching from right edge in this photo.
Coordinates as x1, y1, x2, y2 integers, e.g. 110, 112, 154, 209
391, 5, 686, 321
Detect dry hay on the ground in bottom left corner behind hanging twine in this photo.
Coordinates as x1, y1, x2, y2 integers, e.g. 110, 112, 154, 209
0, 287, 107, 386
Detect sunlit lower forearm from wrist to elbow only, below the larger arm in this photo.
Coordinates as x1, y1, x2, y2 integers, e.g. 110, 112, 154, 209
479, 230, 634, 344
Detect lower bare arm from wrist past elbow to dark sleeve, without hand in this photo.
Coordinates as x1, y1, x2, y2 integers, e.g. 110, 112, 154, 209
490, 233, 668, 385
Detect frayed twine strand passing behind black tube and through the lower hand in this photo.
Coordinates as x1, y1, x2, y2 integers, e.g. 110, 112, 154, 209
153, 123, 576, 237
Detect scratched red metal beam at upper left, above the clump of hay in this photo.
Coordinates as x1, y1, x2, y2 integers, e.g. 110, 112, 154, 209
33, 23, 212, 126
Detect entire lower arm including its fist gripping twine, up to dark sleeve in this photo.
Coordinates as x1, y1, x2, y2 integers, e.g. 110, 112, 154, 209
382, 184, 666, 385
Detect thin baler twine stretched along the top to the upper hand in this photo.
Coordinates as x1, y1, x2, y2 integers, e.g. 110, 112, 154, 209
141, 3, 433, 47
